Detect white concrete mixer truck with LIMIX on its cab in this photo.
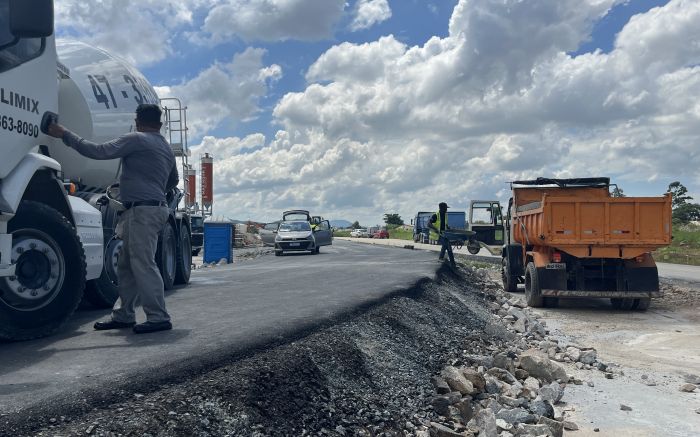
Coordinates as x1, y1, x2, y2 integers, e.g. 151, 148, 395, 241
0, 0, 191, 340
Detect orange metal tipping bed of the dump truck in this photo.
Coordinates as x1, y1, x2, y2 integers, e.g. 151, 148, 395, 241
513, 187, 671, 259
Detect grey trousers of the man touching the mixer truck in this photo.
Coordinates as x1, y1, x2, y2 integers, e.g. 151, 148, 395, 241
112, 206, 170, 323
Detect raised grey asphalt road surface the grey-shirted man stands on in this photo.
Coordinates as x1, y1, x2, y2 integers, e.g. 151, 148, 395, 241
0, 241, 440, 418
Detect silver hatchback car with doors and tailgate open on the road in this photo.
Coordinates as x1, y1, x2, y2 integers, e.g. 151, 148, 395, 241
275, 220, 333, 256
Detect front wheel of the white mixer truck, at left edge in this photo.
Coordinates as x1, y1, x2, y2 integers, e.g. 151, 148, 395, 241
0, 200, 87, 340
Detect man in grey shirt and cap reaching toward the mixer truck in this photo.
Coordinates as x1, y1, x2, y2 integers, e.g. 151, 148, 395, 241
48, 104, 178, 334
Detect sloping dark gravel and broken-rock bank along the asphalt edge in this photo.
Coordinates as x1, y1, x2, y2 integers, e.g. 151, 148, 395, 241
0, 260, 600, 437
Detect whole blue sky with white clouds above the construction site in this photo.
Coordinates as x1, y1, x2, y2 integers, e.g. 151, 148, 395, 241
56, 0, 700, 225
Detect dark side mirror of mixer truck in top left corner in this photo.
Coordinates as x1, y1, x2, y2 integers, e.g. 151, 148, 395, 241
10, 0, 53, 38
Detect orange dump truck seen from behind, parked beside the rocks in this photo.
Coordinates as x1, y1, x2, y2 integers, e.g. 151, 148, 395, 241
502, 178, 671, 310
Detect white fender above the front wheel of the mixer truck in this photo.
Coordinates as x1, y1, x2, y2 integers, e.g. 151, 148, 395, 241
0, 153, 61, 215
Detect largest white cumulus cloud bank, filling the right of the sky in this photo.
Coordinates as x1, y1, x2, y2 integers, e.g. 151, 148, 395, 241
194, 0, 700, 224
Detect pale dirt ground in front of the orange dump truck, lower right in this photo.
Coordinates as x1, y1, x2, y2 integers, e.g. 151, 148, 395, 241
504, 275, 700, 436
